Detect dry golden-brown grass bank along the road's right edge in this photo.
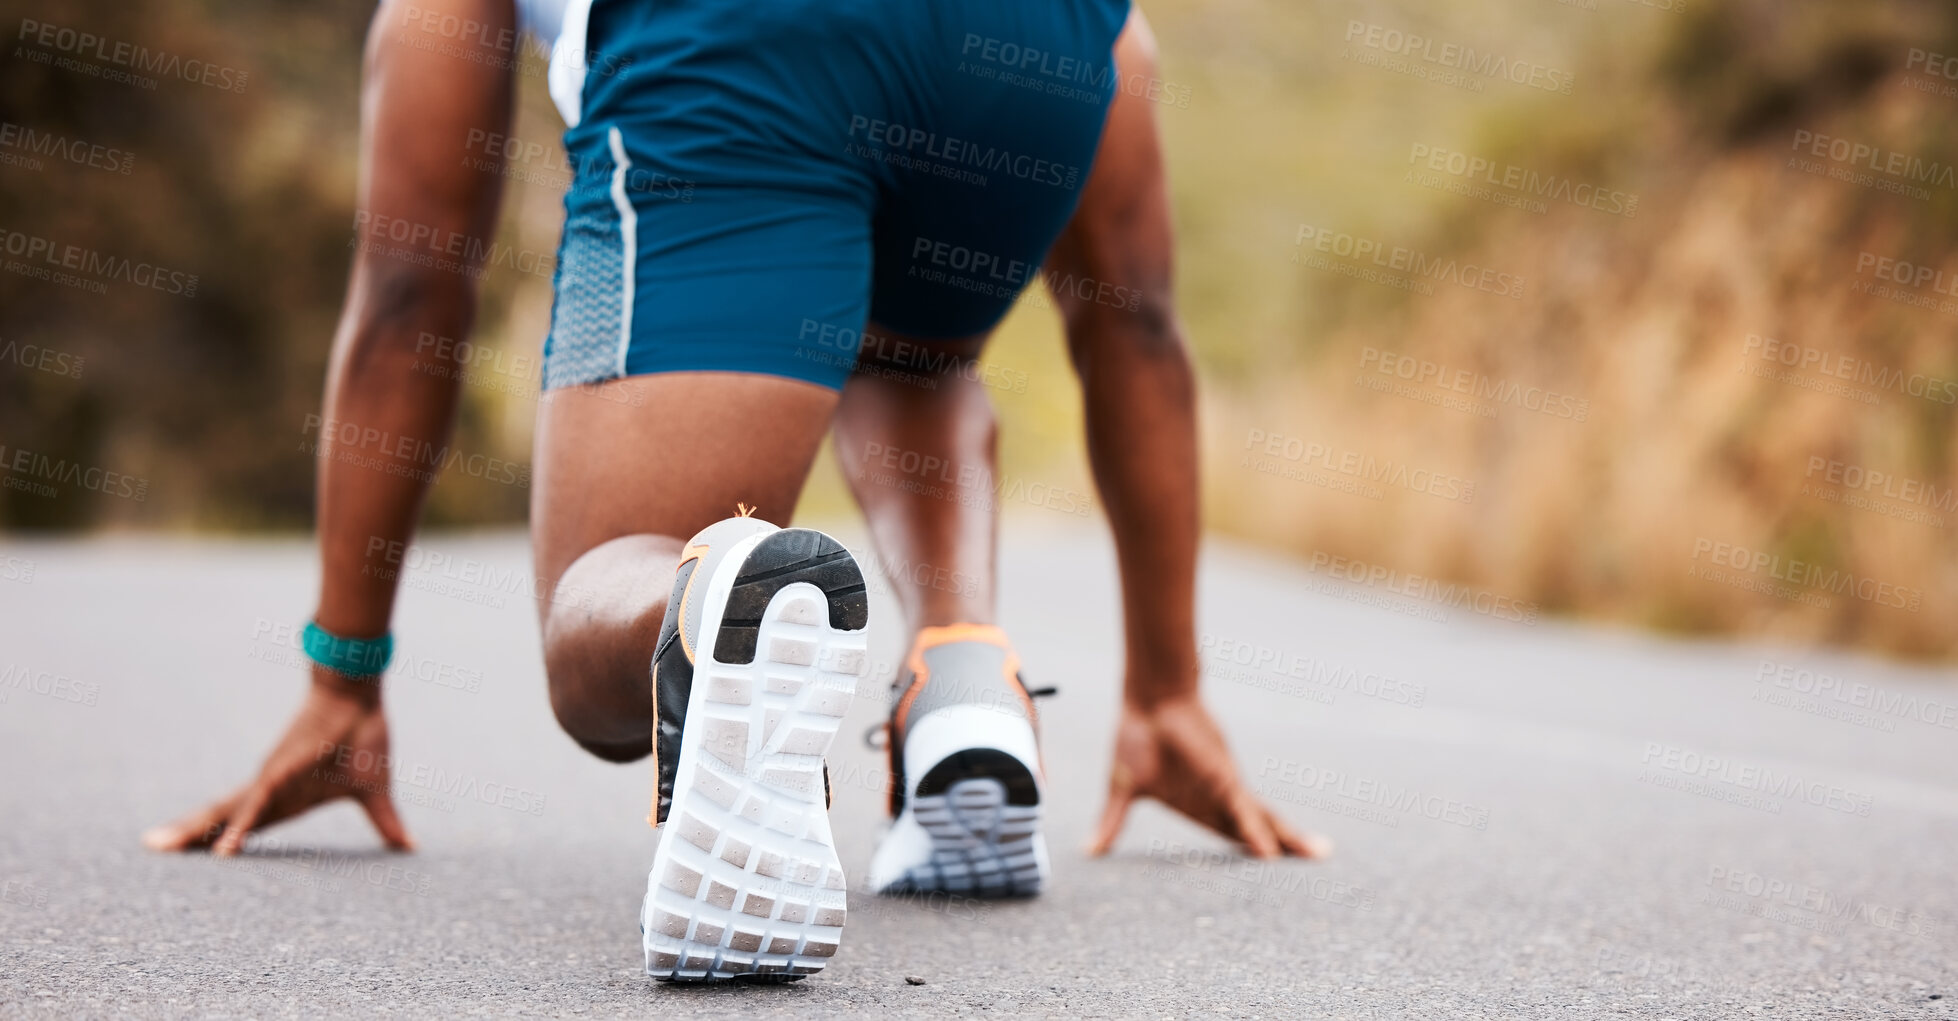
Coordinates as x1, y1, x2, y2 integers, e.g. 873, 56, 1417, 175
1208, 75, 1958, 655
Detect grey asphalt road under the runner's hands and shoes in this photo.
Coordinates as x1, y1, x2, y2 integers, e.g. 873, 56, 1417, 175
0, 525, 1958, 1019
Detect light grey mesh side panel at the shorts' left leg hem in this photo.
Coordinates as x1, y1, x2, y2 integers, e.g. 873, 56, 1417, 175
544, 214, 627, 390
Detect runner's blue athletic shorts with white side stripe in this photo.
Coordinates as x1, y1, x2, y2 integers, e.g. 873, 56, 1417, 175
544, 0, 1128, 388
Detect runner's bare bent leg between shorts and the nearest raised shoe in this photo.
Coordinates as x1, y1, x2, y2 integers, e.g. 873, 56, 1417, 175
531, 372, 836, 762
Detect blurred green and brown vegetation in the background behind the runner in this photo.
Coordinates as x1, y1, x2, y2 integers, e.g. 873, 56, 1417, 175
0, 0, 1958, 655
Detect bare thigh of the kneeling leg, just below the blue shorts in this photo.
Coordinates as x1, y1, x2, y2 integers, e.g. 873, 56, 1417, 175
531, 372, 836, 596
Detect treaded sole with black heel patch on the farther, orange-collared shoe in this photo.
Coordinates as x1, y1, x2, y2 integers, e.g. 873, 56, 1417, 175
889, 749, 1042, 898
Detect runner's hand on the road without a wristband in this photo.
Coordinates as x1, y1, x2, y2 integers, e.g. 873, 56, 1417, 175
1089, 694, 1331, 858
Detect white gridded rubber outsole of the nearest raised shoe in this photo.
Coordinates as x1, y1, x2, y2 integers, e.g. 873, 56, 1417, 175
640, 533, 865, 980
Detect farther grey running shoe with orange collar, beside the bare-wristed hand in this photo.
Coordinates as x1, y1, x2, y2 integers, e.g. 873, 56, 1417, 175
869, 623, 1049, 898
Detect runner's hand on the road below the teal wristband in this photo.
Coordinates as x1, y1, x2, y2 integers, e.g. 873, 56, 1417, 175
143, 684, 415, 856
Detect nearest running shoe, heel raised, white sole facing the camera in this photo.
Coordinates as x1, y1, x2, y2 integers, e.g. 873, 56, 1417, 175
640, 515, 869, 980
